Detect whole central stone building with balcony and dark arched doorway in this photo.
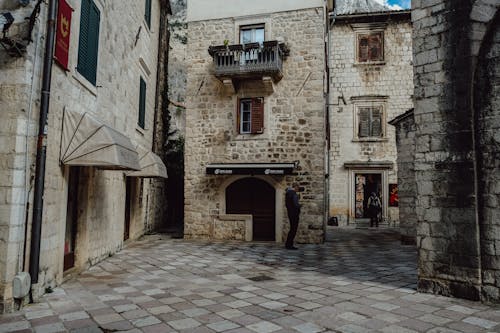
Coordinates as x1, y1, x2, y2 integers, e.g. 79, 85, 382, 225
184, 0, 327, 243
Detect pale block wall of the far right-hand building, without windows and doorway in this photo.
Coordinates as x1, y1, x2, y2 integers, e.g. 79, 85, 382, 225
329, 19, 413, 225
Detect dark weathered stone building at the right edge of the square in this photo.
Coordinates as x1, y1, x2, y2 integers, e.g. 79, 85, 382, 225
396, 0, 500, 302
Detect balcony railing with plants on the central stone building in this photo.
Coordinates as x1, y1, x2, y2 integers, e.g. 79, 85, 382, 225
208, 41, 289, 81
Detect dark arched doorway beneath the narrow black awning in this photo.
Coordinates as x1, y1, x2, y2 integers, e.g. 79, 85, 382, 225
226, 178, 276, 241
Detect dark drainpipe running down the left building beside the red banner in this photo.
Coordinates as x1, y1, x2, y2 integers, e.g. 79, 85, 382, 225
29, 0, 57, 284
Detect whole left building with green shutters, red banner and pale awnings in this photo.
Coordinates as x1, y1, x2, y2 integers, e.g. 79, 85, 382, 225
0, 0, 169, 312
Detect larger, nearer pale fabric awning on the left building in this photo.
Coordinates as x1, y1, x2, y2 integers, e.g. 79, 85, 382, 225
60, 108, 141, 170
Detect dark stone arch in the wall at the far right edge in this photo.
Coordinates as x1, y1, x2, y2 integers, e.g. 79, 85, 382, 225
472, 9, 500, 302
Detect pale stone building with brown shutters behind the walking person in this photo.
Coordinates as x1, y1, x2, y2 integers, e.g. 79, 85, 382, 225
328, 0, 413, 226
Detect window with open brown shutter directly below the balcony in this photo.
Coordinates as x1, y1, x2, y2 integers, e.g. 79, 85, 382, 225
237, 97, 264, 134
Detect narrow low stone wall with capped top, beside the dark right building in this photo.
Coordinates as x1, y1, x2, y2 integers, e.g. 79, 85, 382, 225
391, 110, 417, 245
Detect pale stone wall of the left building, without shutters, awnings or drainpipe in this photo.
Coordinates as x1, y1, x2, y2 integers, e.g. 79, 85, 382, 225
0, 0, 166, 312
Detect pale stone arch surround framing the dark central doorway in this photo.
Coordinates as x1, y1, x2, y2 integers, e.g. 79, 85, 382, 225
216, 175, 286, 242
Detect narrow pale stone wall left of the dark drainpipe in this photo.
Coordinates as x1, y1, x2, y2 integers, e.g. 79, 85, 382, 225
0, 0, 46, 313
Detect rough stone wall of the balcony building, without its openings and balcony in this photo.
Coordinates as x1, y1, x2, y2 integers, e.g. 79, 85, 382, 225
184, 8, 325, 242
